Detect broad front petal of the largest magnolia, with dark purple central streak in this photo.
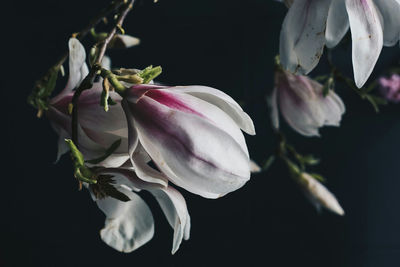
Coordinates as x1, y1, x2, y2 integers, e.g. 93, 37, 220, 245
130, 97, 250, 198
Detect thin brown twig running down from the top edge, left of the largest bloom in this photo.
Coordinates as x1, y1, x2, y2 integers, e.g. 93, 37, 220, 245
71, 0, 134, 145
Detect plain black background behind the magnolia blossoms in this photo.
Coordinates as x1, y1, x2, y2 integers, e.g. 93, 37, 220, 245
0, 0, 400, 267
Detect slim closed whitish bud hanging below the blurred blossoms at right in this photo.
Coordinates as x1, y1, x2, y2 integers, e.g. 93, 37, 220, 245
297, 172, 344, 215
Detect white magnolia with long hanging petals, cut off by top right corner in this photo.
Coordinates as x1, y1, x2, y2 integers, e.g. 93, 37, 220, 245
279, 0, 400, 87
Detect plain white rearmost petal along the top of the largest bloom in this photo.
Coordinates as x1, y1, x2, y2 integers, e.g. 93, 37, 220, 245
168, 85, 256, 135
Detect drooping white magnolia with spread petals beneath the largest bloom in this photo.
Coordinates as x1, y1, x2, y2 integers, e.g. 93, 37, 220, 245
91, 168, 190, 254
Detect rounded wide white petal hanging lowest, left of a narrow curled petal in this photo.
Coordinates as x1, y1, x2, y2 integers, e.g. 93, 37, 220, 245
96, 188, 154, 253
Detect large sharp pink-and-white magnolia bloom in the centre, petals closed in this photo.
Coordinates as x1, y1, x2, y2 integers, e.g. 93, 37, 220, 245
122, 85, 255, 198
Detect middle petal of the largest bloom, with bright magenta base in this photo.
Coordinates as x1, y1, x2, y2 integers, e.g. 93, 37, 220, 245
146, 89, 249, 159
